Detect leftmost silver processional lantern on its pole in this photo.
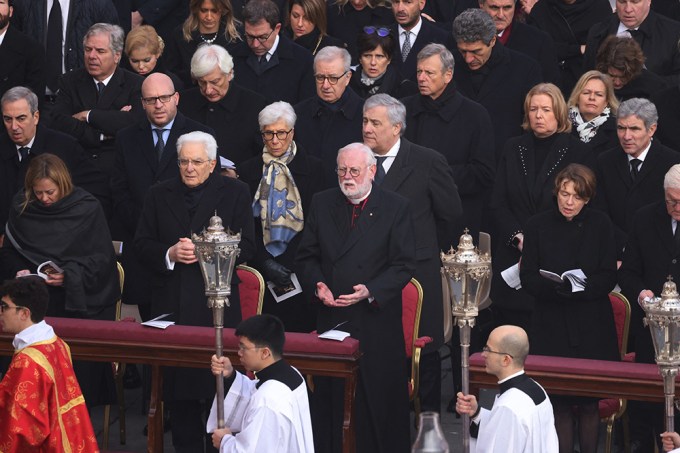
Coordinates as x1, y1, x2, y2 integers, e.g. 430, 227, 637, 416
191, 212, 241, 428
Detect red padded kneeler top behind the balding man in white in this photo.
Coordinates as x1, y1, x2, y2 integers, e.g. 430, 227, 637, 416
470, 353, 680, 402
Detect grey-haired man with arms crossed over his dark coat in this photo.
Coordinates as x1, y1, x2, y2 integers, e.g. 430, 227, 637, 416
50, 24, 143, 175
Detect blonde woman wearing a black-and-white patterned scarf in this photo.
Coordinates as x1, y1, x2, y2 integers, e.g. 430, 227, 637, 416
567, 71, 619, 155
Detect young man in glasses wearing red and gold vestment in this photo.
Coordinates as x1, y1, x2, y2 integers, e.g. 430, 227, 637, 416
0, 277, 99, 452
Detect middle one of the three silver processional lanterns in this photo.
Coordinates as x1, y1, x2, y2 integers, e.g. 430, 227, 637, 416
441, 228, 491, 453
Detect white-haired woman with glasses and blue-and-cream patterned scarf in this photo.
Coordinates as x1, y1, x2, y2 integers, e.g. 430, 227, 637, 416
237, 102, 324, 332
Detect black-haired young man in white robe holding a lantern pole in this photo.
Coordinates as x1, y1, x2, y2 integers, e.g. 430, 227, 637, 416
207, 315, 314, 453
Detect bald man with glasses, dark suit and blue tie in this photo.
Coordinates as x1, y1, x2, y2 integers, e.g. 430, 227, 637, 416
111, 72, 213, 319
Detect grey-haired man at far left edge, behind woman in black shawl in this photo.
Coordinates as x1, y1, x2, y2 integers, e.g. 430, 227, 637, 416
0, 86, 111, 231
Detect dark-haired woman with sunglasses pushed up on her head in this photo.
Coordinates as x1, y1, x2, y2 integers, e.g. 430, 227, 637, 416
349, 26, 418, 99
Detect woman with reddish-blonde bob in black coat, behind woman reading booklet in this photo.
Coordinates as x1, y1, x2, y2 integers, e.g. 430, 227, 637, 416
491, 83, 592, 332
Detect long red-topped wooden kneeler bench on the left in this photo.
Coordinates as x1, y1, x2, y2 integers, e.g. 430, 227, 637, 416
0, 318, 361, 453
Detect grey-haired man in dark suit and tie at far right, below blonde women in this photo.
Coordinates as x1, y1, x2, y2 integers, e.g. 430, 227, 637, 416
594, 98, 680, 260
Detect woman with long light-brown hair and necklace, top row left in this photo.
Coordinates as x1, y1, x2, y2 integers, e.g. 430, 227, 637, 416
167, 0, 242, 86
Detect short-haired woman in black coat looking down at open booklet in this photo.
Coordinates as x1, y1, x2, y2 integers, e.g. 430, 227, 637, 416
520, 164, 619, 453
